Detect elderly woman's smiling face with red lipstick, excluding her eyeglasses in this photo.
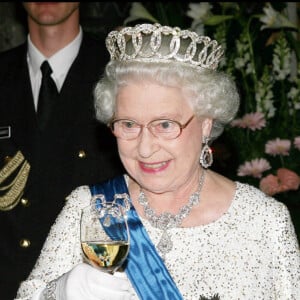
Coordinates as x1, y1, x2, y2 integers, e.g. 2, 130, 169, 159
115, 81, 209, 193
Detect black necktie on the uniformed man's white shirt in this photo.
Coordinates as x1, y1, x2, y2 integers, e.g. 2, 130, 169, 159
37, 60, 58, 129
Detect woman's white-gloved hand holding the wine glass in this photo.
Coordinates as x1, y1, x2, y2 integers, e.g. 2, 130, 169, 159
52, 263, 134, 300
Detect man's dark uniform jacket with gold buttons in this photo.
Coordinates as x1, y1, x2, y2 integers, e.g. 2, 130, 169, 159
0, 34, 123, 300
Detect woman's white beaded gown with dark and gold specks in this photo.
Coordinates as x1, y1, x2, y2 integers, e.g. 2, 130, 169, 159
16, 176, 300, 300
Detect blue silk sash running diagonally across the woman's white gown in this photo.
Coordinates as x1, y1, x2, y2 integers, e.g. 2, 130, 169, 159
90, 175, 183, 300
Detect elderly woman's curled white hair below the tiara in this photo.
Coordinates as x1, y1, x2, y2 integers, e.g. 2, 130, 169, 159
94, 60, 239, 140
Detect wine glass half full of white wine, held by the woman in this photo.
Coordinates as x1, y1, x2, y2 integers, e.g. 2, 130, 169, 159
80, 197, 130, 274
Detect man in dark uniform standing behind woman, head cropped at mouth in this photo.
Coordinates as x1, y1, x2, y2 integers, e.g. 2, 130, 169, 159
0, 2, 123, 300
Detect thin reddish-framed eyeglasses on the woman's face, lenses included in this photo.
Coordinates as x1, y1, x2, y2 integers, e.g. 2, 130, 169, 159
108, 115, 194, 140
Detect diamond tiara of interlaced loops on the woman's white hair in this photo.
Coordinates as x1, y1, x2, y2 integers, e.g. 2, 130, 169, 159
106, 23, 224, 70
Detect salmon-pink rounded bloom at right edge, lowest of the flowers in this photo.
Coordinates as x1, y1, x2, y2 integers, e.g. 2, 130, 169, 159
259, 168, 300, 196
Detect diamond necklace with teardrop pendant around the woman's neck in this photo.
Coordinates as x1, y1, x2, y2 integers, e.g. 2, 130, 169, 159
138, 170, 205, 260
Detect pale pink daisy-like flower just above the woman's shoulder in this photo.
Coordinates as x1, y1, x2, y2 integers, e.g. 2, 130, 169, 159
238, 158, 271, 178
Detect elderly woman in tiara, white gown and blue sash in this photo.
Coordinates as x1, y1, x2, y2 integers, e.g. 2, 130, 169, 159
17, 24, 300, 300
